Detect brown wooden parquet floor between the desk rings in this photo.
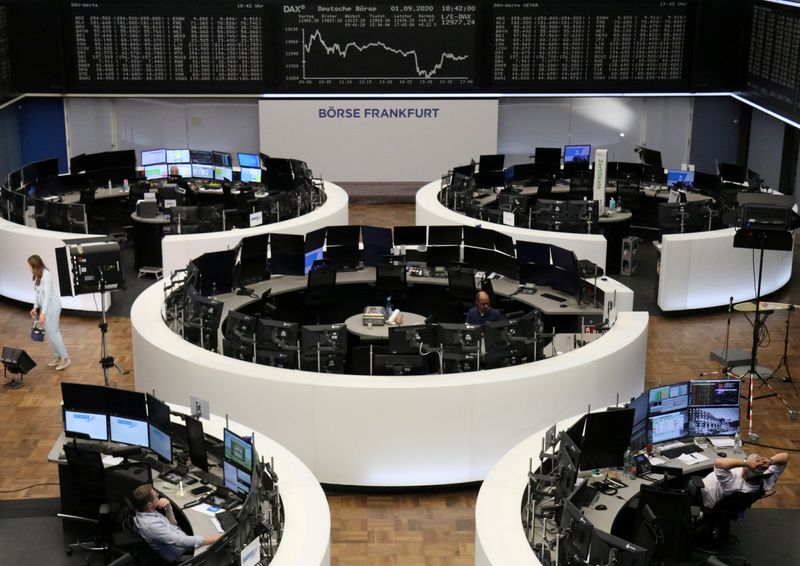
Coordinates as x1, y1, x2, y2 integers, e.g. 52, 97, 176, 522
0, 205, 800, 566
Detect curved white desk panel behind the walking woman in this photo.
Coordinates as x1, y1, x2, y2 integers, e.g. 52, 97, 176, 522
0, 218, 112, 312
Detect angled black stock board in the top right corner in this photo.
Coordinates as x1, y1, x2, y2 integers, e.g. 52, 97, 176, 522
745, 2, 800, 124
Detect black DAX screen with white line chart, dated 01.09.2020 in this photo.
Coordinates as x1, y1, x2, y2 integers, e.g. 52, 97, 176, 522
280, 2, 478, 91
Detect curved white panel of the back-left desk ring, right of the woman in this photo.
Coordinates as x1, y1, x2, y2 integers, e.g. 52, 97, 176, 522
161, 181, 349, 277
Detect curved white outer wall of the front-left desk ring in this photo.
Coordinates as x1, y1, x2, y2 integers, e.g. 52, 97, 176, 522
166, 404, 331, 566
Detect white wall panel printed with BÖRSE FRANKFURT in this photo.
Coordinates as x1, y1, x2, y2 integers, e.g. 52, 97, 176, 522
259, 99, 497, 182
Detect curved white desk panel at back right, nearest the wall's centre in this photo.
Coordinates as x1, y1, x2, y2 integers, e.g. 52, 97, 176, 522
416, 180, 606, 269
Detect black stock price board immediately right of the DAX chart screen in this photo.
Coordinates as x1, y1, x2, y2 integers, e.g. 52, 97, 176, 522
490, 0, 693, 91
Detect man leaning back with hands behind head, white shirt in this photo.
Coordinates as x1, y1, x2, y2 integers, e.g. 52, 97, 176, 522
703, 452, 789, 509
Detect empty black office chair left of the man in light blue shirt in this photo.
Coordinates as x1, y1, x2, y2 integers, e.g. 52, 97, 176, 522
57, 443, 107, 564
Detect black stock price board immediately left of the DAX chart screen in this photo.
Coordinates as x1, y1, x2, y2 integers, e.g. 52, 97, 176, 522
66, 0, 266, 92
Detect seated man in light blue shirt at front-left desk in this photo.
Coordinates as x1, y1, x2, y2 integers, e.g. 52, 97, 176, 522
133, 483, 222, 563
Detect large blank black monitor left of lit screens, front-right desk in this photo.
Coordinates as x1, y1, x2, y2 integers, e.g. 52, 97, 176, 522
580, 409, 635, 470
